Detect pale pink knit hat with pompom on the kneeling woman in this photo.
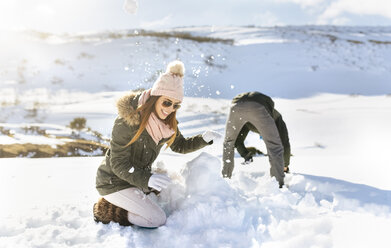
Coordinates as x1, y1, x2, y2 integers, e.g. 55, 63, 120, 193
151, 60, 185, 102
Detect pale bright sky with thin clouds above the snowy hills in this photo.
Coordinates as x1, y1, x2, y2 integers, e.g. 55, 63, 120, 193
0, 0, 391, 33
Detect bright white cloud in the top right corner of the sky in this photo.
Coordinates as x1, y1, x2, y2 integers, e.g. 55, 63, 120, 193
318, 0, 391, 24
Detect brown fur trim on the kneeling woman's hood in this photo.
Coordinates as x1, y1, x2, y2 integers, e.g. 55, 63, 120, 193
117, 91, 141, 126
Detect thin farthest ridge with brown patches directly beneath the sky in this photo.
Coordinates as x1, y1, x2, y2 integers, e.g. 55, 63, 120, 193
18, 25, 391, 45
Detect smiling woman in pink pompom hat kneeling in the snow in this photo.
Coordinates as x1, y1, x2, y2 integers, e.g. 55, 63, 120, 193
94, 61, 216, 227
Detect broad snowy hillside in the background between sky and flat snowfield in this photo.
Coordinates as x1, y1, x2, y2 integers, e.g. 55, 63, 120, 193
0, 26, 391, 102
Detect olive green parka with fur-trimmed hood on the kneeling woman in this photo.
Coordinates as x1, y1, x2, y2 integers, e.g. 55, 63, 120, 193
96, 92, 212, 196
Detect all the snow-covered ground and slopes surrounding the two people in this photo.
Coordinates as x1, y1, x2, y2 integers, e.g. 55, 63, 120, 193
0, 27, 391, 248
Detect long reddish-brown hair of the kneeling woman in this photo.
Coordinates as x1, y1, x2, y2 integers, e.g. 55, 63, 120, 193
126, 96, 178, 147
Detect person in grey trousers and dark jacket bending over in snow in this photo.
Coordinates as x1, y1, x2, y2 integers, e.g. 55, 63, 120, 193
222, 92, 291, 187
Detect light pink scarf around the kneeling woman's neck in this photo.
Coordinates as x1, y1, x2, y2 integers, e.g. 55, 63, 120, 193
138, 89, 175, 145
